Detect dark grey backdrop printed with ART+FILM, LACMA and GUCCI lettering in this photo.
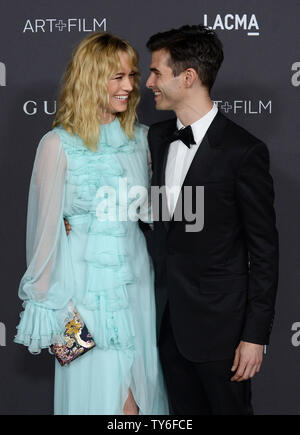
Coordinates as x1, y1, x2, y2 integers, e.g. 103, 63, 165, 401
0, 0, 300, 414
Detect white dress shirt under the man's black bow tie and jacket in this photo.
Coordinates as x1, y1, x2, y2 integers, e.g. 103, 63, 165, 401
165, 103, 218, 216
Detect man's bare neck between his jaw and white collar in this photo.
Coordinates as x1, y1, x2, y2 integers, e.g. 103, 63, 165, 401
175, 95, 214, 126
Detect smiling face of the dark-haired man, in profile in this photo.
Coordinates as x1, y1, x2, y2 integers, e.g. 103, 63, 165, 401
146, 49, 184, 111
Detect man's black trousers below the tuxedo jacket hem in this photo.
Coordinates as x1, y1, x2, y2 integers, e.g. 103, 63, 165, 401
159, 306, 253, 415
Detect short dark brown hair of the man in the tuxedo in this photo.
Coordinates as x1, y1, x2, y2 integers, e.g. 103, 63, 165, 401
147, 24, 224, 90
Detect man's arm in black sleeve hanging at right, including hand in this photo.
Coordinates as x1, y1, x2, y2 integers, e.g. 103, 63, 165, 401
232, 142, 278, 381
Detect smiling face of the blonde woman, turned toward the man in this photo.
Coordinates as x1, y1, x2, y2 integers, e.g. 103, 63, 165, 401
108, 52, 136, 114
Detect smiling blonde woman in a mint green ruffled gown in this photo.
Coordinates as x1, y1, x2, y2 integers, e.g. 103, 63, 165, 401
15, 33, 168, 414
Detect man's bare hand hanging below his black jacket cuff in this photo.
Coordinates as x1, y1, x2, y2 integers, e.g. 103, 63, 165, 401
231, 341, 264, 382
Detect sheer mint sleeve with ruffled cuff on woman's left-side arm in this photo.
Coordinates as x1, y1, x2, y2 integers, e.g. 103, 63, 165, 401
14, 132, 73, 353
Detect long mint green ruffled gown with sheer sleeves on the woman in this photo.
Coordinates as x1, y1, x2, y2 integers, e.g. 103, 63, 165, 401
15, 118, 168, 415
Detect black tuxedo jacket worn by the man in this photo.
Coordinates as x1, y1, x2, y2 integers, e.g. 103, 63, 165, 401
148, 112, 278, 362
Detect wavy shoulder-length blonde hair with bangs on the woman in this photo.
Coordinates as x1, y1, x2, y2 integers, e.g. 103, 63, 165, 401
53, 32, 140, 150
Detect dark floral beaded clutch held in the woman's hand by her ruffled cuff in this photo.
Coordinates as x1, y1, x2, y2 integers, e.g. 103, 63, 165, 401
51, 309, 96, 366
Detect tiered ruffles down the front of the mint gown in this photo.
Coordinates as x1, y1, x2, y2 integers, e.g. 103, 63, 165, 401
57, 120, 136, 349
